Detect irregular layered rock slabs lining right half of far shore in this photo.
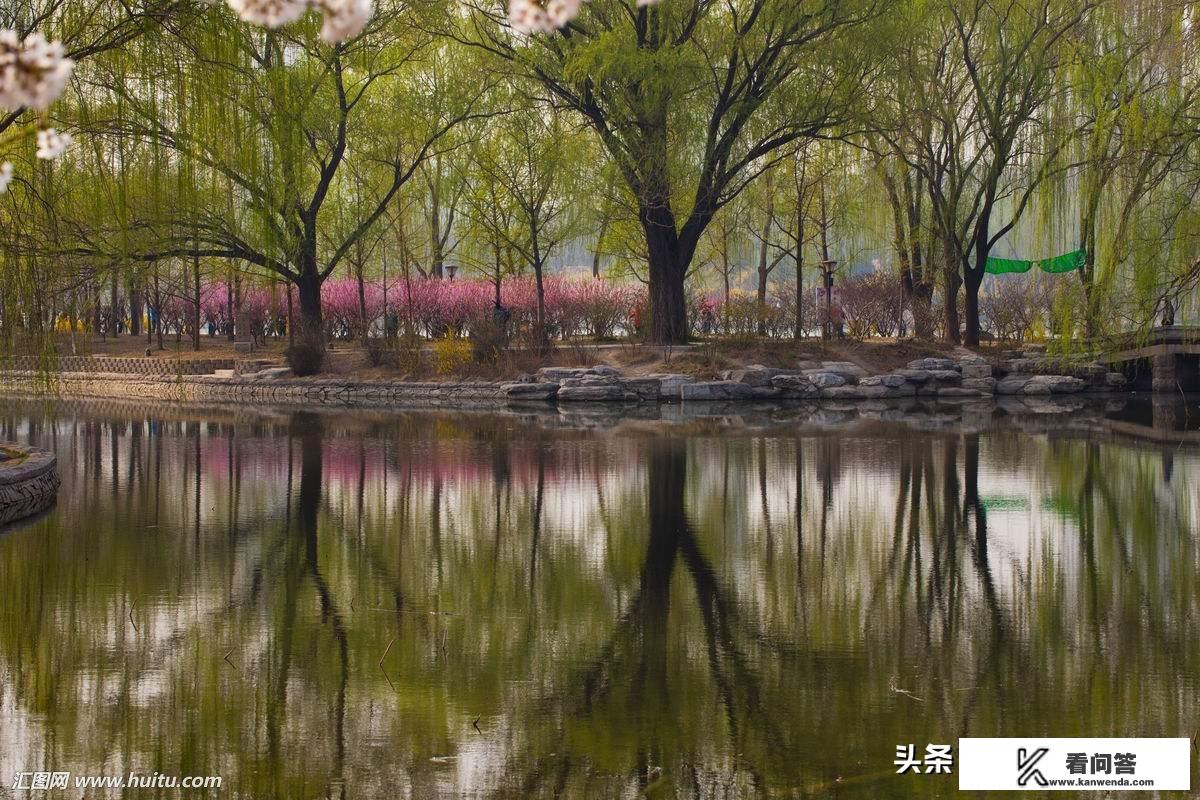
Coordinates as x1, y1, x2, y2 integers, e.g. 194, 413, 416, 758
502, 356, 1126, 403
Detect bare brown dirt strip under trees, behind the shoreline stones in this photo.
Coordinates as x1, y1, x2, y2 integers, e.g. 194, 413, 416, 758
25, 336, 1003, 380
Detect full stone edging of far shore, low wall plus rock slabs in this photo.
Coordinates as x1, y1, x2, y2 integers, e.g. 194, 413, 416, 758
0, 355, 1128, 408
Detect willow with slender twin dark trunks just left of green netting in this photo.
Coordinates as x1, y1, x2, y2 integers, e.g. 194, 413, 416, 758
882, 0, 1093, 345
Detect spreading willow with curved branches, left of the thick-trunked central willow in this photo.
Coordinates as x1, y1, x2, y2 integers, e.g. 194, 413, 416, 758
78, 2, 480, 363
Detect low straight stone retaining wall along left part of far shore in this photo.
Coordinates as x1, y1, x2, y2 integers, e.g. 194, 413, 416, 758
0, 372, 505, 408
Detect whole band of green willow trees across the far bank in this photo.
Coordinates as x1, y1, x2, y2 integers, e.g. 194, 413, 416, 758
0, 0, 1200, 353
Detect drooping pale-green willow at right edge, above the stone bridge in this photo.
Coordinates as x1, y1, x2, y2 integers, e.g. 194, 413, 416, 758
1055, 0, 1200, 336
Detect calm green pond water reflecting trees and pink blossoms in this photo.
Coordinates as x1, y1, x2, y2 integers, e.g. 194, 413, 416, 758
0, 402, 1200, 799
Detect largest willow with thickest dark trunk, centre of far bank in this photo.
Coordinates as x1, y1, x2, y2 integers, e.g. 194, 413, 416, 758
456, 0, 887, 343
